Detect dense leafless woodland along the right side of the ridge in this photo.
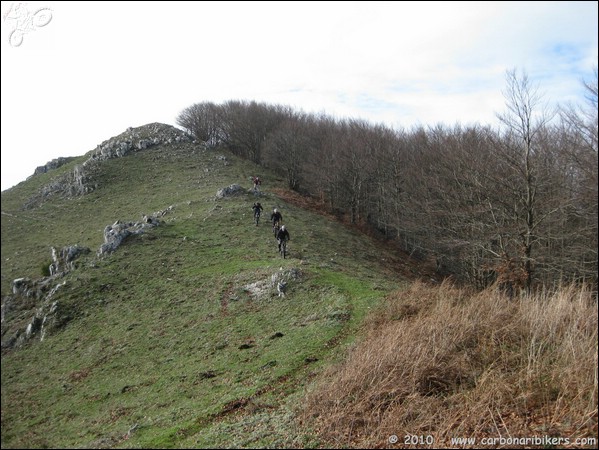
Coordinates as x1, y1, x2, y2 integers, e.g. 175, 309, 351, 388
177, 70, 598, 293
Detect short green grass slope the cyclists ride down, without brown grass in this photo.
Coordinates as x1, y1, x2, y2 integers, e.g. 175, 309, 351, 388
1, 128, 401, 448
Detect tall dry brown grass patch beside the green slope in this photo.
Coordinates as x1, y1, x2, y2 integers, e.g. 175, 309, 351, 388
303, 283, 597, 448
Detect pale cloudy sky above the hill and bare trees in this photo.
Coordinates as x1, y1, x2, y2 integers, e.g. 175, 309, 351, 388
0, 1, 598, 191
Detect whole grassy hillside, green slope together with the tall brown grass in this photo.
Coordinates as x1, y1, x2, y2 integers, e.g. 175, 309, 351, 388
1, 124, 598, 448
